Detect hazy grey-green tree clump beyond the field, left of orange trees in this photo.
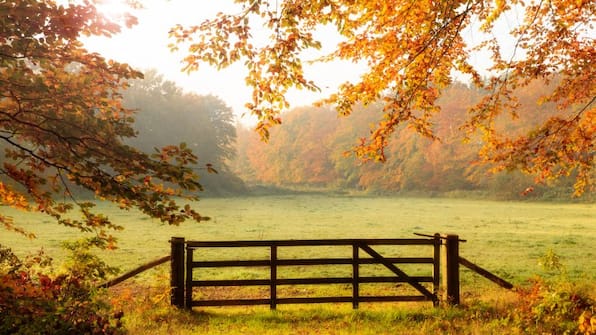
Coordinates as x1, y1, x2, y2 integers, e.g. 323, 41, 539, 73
123, 70, 243, 193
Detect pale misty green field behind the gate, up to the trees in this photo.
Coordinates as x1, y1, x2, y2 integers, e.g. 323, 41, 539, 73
0, 195, 596, 285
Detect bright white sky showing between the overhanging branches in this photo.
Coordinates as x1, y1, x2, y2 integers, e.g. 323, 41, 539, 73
84, 0, 362, 123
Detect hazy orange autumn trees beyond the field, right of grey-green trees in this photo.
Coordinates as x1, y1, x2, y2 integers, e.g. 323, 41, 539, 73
231, 81, 590, 200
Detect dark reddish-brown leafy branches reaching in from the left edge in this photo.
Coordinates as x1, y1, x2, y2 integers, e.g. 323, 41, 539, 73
0, 0, 202, 246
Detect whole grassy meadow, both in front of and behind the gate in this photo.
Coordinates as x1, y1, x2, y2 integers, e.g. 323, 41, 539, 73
0, 195, 596, 334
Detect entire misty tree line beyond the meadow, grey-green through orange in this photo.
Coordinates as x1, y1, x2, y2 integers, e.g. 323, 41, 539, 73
1, 70, 576, 201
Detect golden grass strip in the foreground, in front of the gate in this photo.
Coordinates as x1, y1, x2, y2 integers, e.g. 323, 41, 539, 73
112, 278, 572, 335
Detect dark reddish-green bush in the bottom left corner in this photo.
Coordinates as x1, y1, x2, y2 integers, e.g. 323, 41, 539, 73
0, 244, 124, 334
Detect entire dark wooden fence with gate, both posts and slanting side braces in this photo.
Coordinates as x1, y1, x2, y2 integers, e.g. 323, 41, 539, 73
98, 234, 514, 309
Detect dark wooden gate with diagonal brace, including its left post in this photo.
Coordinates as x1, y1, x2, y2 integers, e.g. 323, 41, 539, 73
171, 234, 441, 309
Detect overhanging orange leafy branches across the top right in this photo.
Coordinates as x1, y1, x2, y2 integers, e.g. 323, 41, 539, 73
170, 0, 596, 195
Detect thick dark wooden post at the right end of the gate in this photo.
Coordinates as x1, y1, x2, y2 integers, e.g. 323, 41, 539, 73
442, 234, 459, 305
